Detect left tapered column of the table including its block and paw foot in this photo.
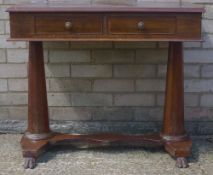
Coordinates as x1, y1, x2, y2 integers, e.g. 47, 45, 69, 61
21, 42, 52, 168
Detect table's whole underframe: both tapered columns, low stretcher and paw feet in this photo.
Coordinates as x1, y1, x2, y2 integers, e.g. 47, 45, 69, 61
21, 42, 192, 168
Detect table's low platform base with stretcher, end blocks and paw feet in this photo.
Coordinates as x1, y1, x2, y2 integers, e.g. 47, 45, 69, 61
21, 133, 192, 169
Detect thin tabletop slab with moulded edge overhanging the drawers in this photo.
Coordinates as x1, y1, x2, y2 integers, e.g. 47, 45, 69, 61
6, 2, 205, 13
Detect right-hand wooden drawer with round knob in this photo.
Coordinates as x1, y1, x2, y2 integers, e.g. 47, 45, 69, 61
107, 15, 176, 35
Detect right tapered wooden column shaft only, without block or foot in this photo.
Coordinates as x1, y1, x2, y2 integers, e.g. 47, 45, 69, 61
163, 42, 186, 137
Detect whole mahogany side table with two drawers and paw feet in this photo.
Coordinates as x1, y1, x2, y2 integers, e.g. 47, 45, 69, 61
7, 1, 204, 168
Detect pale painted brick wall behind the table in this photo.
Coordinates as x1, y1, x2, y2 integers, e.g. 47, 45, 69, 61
0, 0, 213, 134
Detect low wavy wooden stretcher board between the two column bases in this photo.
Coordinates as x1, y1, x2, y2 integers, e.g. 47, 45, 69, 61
49, 133, 164, 146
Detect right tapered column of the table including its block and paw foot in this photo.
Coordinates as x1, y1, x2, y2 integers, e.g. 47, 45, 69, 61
162, 42, 192, 168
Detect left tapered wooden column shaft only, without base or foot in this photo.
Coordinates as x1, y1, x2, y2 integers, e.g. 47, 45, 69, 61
27, 42, 50, 135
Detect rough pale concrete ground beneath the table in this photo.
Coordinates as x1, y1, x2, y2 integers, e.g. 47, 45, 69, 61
0, 134, 213, 175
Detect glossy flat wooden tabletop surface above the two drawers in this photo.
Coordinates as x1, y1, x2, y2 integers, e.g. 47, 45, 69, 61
7, 0, 204, 13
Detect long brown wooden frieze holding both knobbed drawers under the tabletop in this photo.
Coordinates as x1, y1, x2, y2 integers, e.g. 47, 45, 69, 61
10, 12, 201, 41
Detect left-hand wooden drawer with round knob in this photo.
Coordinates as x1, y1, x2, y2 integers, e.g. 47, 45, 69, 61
35, 15, 103, 35
